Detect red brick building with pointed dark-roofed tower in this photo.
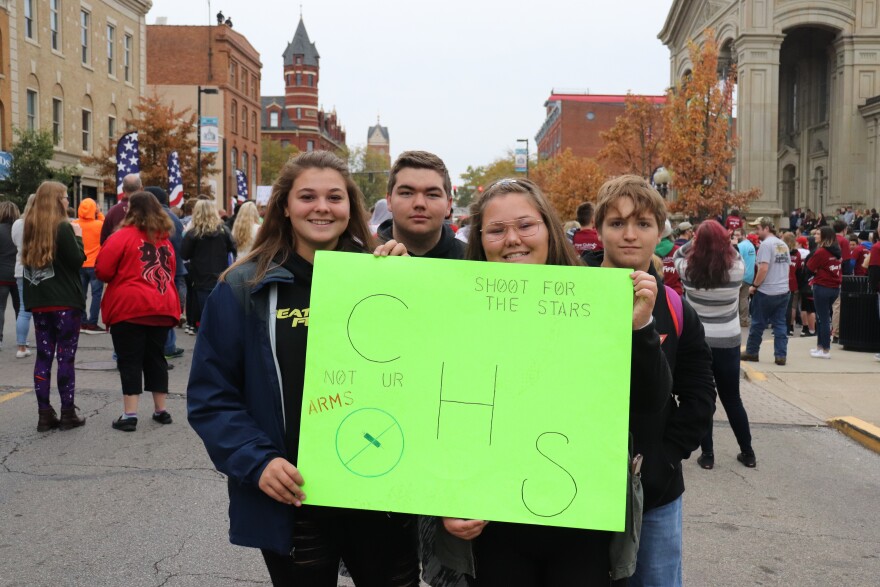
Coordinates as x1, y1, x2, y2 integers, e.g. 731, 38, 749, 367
262, 17, 345, 151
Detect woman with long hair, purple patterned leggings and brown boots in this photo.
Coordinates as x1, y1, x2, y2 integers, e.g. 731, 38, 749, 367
21, 181, 86, 432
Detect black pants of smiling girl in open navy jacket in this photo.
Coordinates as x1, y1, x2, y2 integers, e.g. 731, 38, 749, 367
262, 506, 419, 587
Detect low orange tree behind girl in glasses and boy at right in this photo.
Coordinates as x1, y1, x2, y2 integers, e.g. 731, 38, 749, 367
531, 149, 606, 222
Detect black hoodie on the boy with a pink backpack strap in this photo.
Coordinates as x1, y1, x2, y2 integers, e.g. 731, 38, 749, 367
582, 251, 715, 511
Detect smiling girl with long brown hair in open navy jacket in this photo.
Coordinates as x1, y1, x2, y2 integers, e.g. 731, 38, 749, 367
187, 151, 419, 587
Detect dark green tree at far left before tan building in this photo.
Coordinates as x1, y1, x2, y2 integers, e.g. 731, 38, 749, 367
0, 128, 72, 208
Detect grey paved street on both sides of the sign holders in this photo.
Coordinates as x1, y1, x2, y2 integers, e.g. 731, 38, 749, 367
0, 310, 880, 587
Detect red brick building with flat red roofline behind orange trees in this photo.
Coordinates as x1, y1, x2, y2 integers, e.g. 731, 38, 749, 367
535, 91, 666, 159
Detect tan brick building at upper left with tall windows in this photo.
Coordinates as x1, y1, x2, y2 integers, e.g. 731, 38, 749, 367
9, 0, 152, 204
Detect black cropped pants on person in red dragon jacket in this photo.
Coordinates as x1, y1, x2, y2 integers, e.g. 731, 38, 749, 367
110, 322, 168, 395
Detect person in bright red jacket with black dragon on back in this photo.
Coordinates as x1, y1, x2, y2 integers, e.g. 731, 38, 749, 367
95, 192, 180, 432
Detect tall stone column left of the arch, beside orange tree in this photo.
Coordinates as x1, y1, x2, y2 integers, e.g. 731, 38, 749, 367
735, 35, 788, 215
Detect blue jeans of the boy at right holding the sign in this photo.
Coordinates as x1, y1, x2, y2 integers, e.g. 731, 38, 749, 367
629, 495, 682, 587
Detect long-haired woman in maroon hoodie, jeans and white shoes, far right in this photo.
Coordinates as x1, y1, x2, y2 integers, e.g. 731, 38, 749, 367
807, 225, 843, 359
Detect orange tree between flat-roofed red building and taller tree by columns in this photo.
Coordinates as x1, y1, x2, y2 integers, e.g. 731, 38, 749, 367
598, 94, 663, 179
